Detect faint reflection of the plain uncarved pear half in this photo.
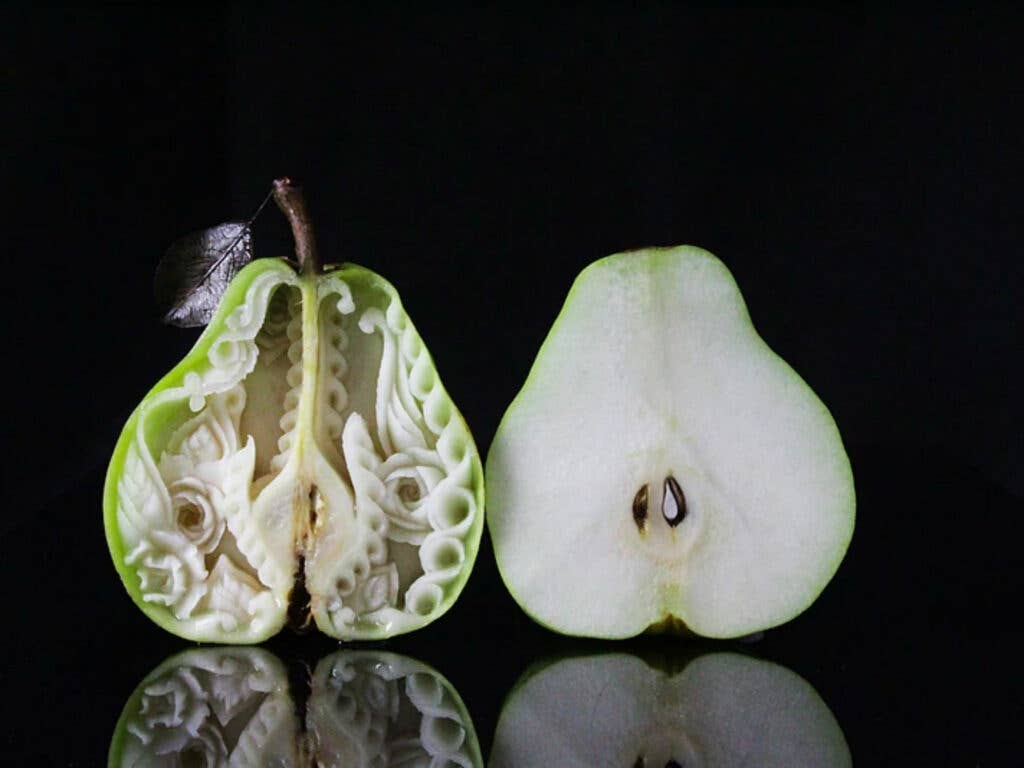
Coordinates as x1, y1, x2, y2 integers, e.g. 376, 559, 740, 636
488, 653, 852, 768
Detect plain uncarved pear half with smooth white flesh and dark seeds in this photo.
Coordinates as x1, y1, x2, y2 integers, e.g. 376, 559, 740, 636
486, 247, 855, 638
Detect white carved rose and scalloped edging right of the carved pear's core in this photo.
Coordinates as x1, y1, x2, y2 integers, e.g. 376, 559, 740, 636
330, 288, 480, 631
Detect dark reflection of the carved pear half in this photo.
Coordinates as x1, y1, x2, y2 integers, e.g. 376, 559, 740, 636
109, 647, 483, 768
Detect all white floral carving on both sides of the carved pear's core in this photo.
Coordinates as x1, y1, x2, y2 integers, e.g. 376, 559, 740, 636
118, 270, 481, 631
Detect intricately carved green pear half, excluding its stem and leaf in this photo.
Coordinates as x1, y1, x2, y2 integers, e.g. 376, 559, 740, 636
103, 259, 483, 643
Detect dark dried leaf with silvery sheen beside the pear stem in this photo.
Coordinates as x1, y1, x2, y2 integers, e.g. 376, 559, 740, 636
154, 221, 253, 328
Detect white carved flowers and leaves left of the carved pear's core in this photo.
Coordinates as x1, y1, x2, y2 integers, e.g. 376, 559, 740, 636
118, 271, 299, 630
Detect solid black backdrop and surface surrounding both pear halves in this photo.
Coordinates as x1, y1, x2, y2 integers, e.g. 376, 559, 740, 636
0, 4, 1024, 766
